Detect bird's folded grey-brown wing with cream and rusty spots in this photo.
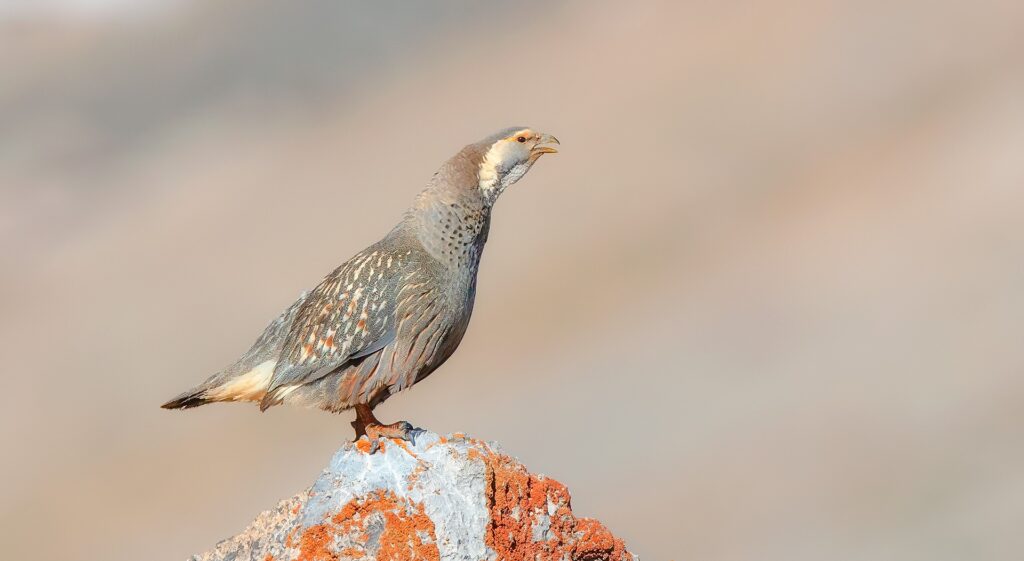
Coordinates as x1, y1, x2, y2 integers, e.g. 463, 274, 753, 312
261, 249, 401, 408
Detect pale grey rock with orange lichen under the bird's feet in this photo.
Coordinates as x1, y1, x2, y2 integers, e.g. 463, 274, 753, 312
191, 432, 636, 561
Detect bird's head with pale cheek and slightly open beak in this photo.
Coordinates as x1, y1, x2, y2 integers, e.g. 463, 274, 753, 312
477, 127, 559, 203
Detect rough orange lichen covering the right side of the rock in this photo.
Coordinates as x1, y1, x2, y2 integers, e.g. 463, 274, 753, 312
481, 454, 632, 561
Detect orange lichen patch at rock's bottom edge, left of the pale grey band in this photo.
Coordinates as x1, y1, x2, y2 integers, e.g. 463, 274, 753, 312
296, 490, 440, 561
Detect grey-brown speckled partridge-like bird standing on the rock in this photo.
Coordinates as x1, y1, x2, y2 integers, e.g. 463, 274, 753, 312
162, 127, 560, 448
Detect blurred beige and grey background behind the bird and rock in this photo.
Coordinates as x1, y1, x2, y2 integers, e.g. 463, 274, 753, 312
0, 0, 1024, 561
